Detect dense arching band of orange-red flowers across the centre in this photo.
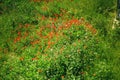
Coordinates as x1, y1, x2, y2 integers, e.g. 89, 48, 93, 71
37, 18, 96, 52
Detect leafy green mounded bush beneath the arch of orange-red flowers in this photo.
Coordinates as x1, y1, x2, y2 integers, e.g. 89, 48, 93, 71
46, 26, 112, 80
